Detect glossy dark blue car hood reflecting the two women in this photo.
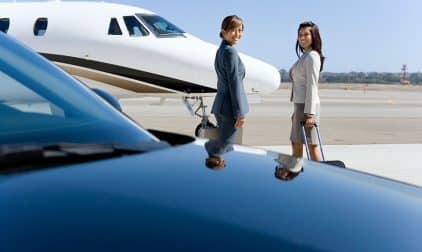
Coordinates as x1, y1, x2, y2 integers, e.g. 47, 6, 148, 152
0, 140, 422, 251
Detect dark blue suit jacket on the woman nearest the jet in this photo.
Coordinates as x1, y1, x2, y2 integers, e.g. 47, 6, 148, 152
211, 40, 249, 119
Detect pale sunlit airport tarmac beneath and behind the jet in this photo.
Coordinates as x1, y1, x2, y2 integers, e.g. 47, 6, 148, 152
88, 79, 422, 187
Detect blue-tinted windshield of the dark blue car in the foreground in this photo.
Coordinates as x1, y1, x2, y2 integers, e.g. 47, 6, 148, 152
0, 34, 158, 147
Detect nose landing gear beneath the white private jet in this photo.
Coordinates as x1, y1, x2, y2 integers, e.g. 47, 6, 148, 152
183, 96, 217, 137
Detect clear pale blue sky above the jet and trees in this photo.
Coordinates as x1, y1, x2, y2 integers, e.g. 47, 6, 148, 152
113, 0, 422, 72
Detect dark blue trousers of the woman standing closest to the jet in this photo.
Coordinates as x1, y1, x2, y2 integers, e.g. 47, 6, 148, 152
205, 114, 238, 157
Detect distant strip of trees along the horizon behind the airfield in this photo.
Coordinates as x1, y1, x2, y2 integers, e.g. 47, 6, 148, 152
280, 69, 422, 84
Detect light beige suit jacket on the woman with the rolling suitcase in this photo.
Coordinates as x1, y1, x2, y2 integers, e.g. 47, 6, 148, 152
290, 50, 321, 114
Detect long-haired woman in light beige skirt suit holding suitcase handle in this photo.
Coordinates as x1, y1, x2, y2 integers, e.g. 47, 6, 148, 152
290, 22, 324, 161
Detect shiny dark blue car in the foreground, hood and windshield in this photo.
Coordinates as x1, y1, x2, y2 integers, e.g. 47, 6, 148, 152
0, 33, 422, 252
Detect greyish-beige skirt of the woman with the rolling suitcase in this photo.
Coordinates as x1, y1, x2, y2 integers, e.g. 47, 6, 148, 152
290, 103, 320, 144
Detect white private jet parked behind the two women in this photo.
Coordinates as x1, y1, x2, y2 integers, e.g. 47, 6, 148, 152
0, 2, 280, 135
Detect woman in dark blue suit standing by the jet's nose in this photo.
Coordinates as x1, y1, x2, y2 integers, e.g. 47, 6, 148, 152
205, 15, 249, 167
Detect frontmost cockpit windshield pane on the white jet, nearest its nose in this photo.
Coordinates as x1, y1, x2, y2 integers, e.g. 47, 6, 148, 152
136, 14, 185, 37
